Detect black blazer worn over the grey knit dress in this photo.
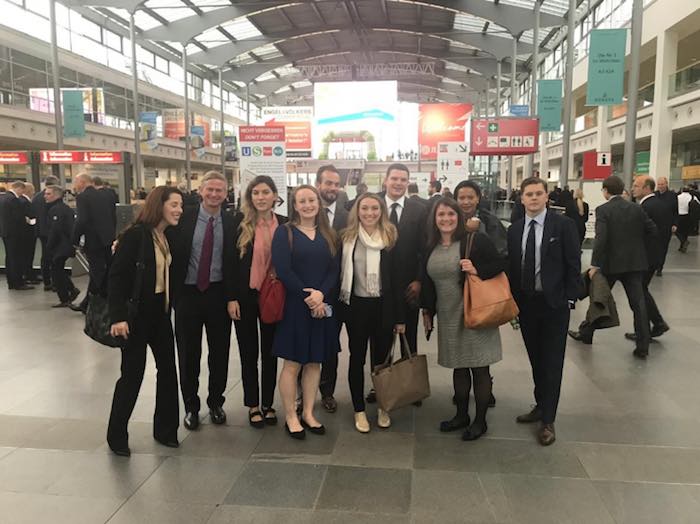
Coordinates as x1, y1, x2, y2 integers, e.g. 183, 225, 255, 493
421, 232, 508, 316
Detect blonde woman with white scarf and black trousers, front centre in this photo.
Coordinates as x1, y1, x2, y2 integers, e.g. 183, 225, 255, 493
339, 193, 406, 433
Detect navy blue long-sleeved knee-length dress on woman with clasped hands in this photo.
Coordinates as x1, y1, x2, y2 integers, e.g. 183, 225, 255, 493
272, 226, 340, 364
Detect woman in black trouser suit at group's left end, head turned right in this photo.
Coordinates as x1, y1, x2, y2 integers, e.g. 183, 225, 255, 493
107, 186, 182, 457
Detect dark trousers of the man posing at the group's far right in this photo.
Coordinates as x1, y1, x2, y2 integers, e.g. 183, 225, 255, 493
518, 294, 570, 424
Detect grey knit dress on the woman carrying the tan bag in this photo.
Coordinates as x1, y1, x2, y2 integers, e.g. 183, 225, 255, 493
427, 242, 502, 369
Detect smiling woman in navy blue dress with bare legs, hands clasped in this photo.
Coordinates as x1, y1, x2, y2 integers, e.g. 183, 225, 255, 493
272, 185, 340, 439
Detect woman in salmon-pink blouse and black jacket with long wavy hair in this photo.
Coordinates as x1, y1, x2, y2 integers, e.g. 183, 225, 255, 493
230, 176, 287, 428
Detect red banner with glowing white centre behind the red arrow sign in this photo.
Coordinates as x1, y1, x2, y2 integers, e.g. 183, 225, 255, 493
418, 104, 472, 160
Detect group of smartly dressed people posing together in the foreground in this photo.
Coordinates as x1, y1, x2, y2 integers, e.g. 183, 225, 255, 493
107, 164, 580, 456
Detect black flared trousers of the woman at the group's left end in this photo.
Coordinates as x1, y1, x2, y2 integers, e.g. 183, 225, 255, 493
107, 293, 179, 447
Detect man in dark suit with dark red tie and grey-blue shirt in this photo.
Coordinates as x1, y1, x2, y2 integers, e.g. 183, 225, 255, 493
167, 171, 236, 430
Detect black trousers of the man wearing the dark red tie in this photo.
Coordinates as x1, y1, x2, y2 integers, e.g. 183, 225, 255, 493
175, 282, 231, 413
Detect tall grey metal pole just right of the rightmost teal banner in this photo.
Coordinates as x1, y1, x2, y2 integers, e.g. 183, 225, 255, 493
622, 0, 644, 188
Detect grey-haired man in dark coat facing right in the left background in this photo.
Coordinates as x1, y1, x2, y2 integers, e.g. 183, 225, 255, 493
44, 185, 80, 308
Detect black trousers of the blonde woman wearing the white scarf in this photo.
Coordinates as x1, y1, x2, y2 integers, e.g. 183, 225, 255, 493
347, 296, 393, 412
